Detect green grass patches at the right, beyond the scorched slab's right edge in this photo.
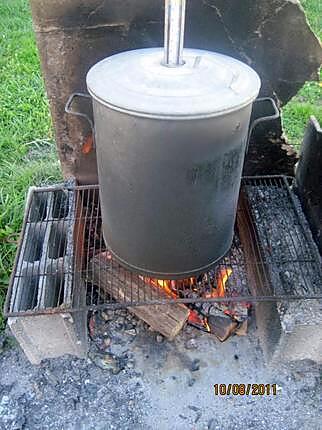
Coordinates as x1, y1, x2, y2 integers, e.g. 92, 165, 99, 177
282, 0, 322, 149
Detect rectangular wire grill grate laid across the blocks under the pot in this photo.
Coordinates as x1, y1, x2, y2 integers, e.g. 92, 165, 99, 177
5, 176, 322, 316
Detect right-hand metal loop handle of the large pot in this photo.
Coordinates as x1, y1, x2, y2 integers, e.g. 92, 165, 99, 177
246, 97, 280, 152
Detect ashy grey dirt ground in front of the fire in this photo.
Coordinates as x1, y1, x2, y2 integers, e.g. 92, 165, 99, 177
0, 311, 322, 430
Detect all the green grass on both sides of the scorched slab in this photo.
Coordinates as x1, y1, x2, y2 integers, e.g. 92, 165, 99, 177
0, 0, 322, 328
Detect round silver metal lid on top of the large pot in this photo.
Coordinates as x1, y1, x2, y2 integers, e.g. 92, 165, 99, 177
86, 48, 260, 119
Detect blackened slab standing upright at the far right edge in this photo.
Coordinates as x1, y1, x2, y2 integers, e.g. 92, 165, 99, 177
296, 116, 322, 253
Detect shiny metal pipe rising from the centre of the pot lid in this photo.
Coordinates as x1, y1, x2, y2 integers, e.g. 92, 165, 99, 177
164, 0, 186, 67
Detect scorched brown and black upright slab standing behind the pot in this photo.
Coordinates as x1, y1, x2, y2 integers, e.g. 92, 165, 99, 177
30, 0, 322, 183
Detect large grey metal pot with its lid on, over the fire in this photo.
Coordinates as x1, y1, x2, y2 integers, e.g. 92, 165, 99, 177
67, 49, 276, 279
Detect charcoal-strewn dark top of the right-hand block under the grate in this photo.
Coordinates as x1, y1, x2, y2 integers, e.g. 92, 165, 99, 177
245, 184, 321, 295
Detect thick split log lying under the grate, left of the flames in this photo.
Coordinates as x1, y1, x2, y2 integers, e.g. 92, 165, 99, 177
91, 252, 189, 340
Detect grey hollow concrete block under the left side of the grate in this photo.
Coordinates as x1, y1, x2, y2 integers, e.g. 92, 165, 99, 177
8, 185, 87, 364
